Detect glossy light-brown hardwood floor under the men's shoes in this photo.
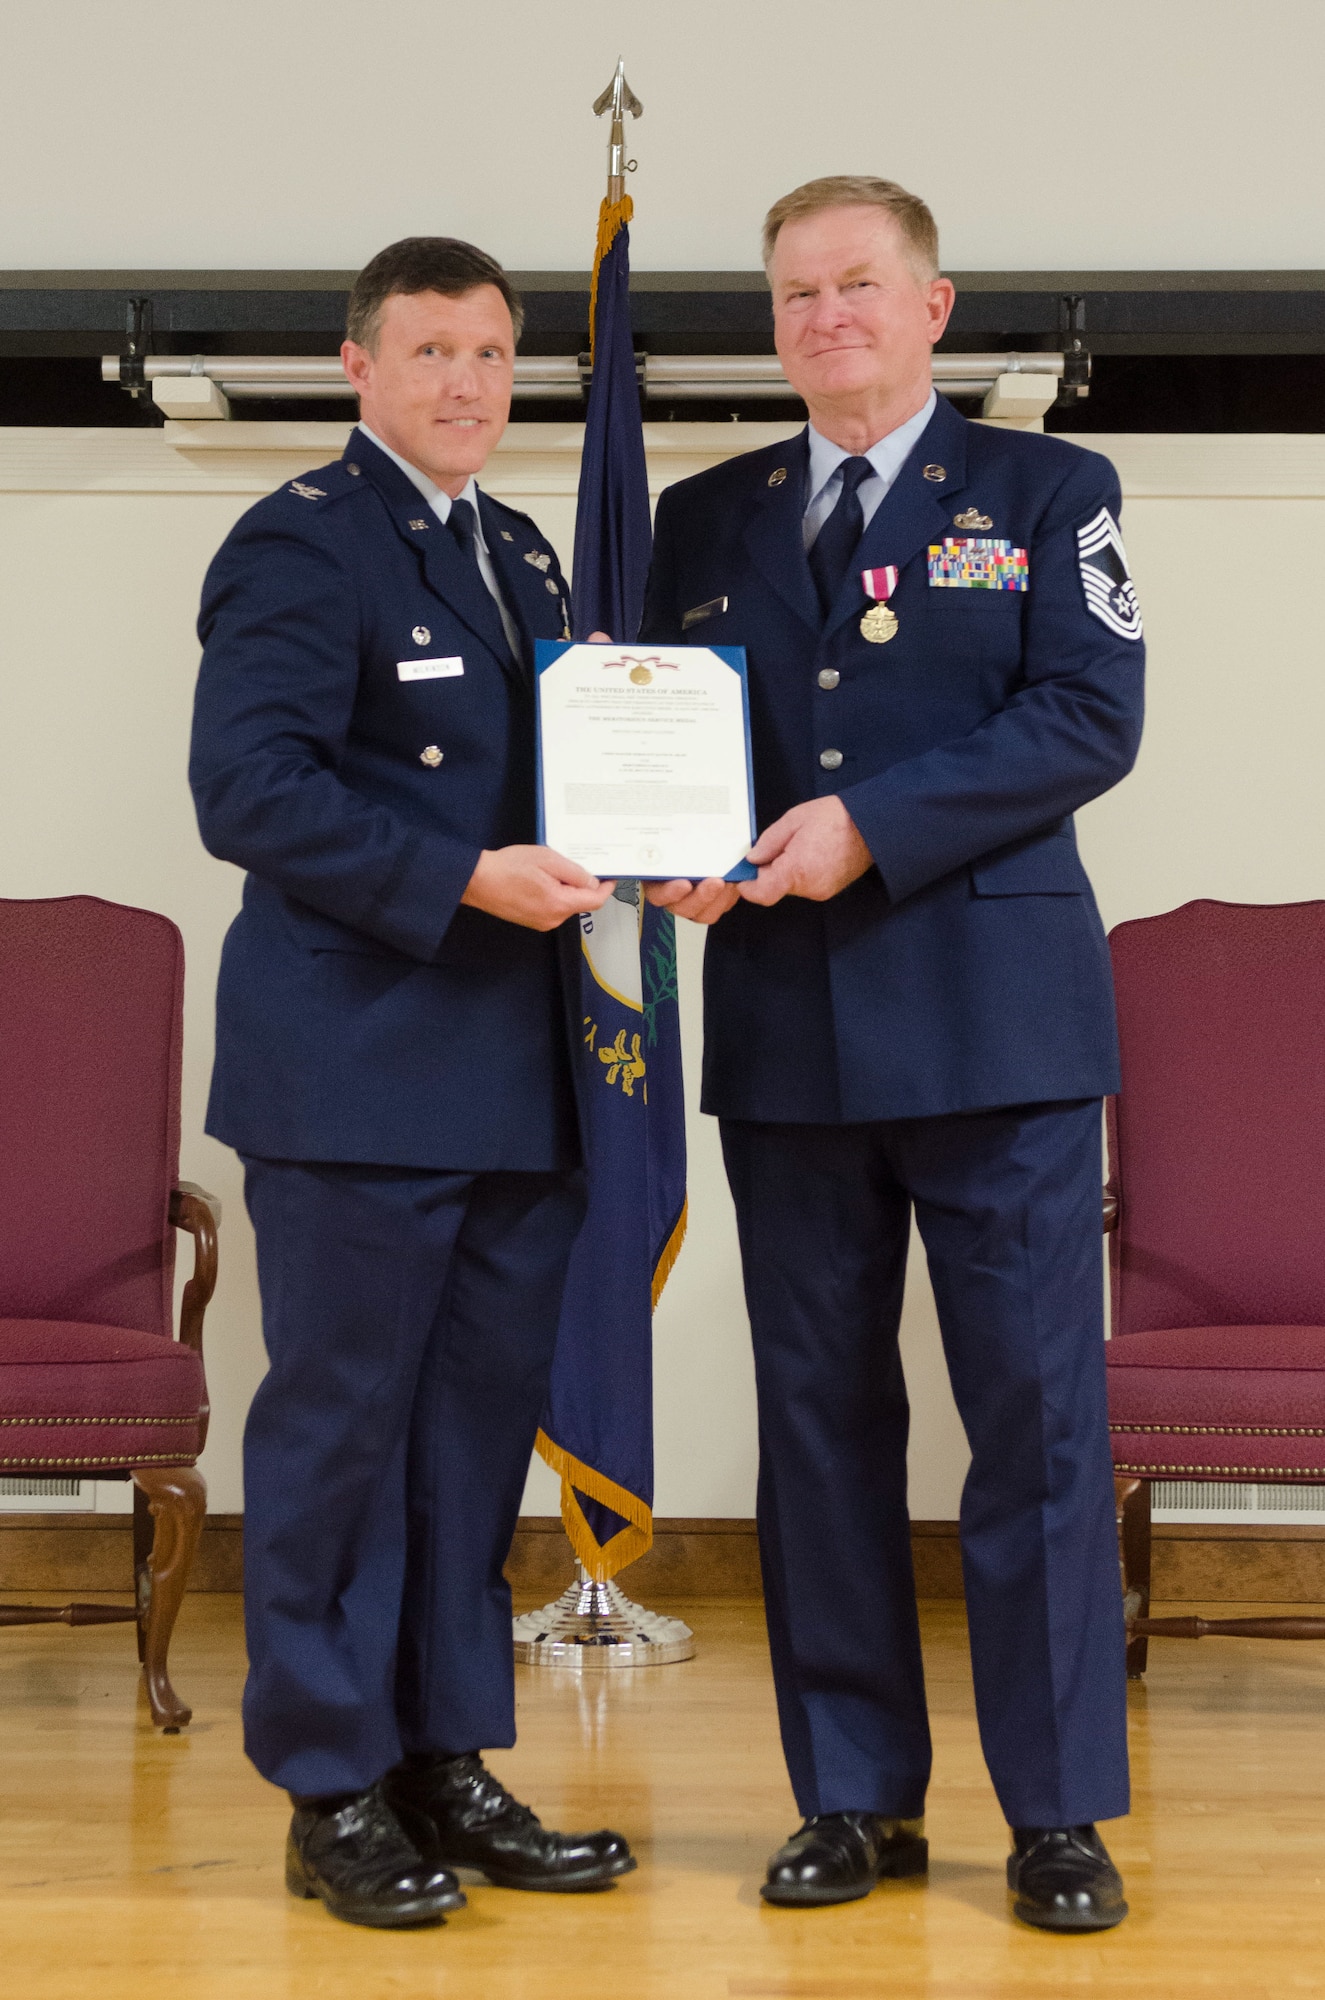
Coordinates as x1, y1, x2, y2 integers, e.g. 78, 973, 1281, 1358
0, 1596, 1325, 2000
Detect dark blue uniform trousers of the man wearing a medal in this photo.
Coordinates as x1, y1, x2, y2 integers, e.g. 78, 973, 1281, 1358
723, 1098, 1127, 1826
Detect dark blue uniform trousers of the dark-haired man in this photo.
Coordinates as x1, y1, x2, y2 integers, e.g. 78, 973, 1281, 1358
244, 1158, 584, 1794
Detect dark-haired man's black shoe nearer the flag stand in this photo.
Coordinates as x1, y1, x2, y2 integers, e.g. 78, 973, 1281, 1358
384, 1750, 634, 1890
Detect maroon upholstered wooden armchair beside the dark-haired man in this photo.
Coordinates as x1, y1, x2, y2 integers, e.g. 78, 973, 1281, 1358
0, 896, 220, 1730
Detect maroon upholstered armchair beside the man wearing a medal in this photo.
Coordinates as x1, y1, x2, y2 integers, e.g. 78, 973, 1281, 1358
1105, 902, 1325, 1676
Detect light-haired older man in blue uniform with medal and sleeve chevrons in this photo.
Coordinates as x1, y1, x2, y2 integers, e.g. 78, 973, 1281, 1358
642, 178, 1143, 1930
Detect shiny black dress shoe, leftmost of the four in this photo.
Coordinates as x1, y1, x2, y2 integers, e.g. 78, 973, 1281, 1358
286, 1784, 464, 1930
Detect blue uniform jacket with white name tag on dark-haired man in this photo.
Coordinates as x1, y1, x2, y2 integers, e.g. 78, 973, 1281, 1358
190, 430, 580, 1170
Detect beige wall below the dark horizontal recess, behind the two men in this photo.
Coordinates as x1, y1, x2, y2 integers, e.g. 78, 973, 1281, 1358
0, 424, 1325, 1518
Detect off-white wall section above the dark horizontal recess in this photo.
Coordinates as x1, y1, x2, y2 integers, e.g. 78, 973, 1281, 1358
0, 0, 1325, 270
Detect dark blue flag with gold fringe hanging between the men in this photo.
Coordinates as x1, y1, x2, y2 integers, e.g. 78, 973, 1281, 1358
538, 198, 685, 1580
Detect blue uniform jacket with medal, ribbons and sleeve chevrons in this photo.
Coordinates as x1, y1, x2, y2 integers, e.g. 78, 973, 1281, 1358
640, 400, 1143, 1124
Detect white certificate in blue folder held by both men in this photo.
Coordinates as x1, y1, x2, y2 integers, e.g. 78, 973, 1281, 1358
536, 640, 755, 882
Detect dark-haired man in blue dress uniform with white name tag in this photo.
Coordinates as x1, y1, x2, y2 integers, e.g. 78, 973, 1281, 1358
190, 238, 634, 1926
